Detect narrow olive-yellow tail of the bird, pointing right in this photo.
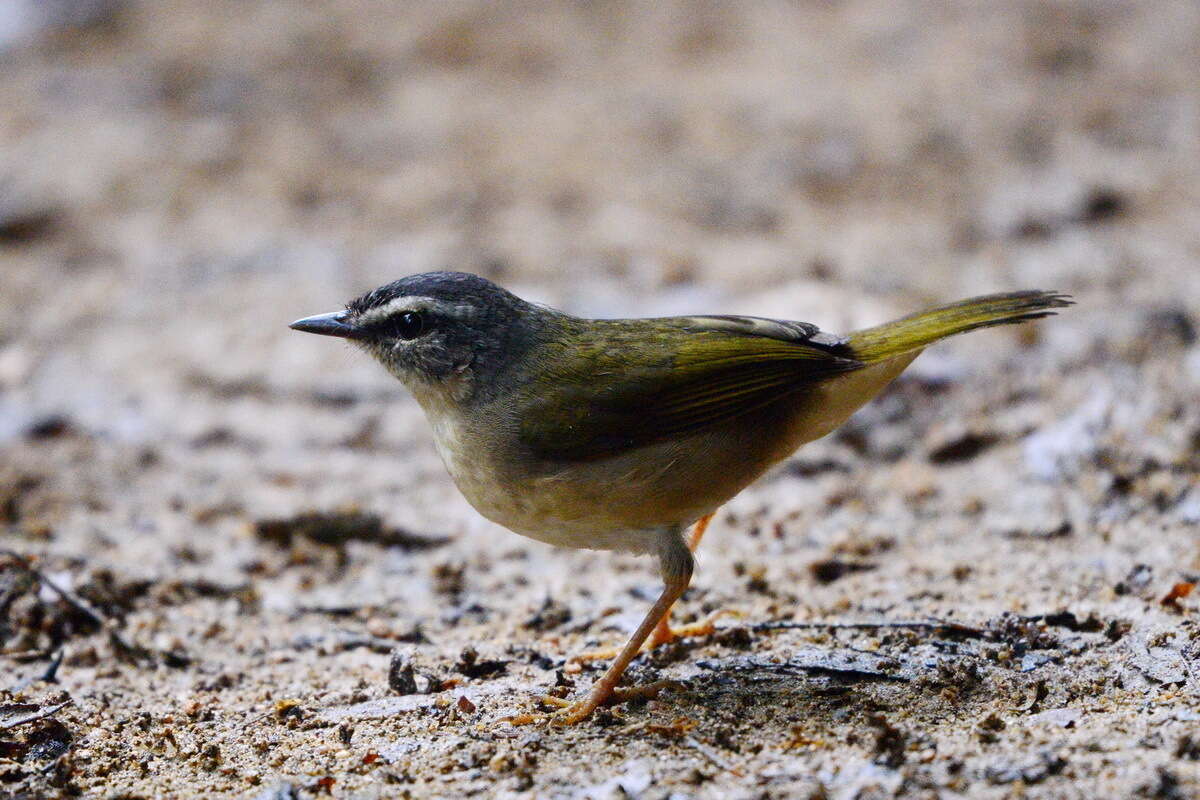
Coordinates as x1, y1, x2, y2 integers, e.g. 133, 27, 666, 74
848, 291, 1072, 363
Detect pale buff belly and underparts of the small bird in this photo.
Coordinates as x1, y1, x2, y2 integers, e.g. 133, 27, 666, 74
426, 353, 918, 553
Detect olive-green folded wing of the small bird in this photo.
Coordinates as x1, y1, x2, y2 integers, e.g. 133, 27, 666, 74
520, 317, 863, 461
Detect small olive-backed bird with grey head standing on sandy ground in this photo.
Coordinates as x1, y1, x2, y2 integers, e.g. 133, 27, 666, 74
290, 272, 1073, 724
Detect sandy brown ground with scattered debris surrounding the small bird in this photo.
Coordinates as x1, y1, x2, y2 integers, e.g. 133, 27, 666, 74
0, 0, 1200, 800
